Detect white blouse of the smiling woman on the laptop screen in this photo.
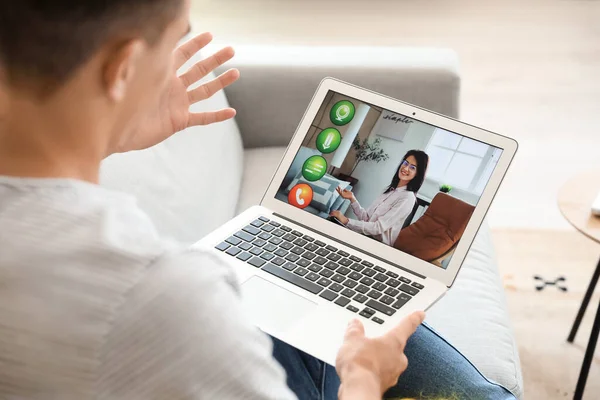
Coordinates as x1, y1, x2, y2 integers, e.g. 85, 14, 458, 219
346, 187, 417, 246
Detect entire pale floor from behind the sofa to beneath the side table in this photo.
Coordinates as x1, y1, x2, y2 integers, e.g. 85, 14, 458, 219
193, 0, 600, 399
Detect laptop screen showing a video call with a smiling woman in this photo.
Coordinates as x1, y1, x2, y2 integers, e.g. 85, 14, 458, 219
276, 91, 502, 269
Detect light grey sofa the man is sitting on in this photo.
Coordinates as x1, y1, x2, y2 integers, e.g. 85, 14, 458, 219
101, 46, 523, 398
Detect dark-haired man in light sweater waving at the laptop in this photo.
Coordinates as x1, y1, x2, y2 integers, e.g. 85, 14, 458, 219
0, 0, 512, 400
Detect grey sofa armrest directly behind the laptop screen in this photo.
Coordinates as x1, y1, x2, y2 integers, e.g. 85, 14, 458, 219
220, 46, 460, 148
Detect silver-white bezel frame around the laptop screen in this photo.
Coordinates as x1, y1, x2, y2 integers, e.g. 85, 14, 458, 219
261, 78, 518, 287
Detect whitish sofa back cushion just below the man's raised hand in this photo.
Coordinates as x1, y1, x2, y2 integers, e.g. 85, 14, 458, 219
101, 69, 243, 244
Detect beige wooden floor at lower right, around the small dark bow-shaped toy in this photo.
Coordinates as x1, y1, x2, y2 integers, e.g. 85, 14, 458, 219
493, 229, 600, 400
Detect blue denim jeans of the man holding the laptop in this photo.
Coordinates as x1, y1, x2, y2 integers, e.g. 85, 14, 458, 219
273, 324, 515, 400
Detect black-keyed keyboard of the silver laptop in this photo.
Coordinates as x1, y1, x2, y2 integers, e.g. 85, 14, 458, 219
216, 217, 424, 324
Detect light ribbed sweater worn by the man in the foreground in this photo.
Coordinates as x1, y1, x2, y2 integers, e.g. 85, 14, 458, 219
0, 177, 294, 400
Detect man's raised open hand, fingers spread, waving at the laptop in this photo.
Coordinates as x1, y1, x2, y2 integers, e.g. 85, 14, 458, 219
111, 33, 240, 153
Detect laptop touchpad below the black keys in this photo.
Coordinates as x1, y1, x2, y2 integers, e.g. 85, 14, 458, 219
242, 276, 317, 333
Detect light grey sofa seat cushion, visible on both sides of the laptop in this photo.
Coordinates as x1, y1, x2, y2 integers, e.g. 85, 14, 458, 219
238, 147, 523, 398
